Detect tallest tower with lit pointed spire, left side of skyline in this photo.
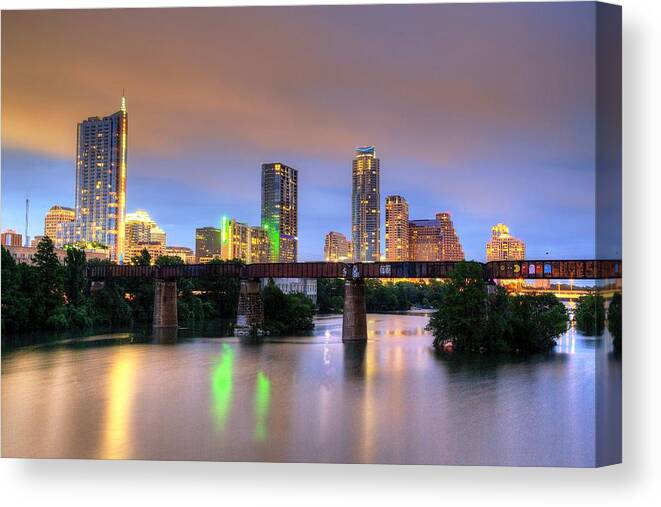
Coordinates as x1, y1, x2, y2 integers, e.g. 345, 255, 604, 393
76, 97, 128, 262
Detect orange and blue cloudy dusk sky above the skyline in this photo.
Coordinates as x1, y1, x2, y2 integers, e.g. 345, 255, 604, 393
2, 3, 620, 261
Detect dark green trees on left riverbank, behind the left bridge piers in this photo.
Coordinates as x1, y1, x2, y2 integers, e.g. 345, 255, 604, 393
1, 237, 315, 343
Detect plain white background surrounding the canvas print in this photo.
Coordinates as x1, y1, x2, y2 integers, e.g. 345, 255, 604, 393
0, 0, 661, 507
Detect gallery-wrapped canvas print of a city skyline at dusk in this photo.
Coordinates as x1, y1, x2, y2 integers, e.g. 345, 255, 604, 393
1, 2, 627, 467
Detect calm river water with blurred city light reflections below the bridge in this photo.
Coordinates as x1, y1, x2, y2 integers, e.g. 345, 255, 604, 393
2, 315, 620, 466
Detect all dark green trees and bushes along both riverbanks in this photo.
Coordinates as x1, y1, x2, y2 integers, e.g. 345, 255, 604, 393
2, 241, 621, 353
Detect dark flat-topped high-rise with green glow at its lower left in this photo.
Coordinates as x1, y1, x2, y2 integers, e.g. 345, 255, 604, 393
262, 162, 298, 262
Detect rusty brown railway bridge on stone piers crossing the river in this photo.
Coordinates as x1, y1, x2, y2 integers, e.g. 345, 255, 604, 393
87, 260, 622, 342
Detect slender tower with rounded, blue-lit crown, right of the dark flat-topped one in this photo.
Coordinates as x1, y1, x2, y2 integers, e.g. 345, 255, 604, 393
351, 146, 381, 262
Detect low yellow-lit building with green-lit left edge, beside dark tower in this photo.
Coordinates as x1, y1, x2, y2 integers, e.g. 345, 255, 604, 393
220, 217, 269, 264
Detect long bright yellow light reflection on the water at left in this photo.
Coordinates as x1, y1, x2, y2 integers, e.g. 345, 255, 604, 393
100, 347, 137, 459
